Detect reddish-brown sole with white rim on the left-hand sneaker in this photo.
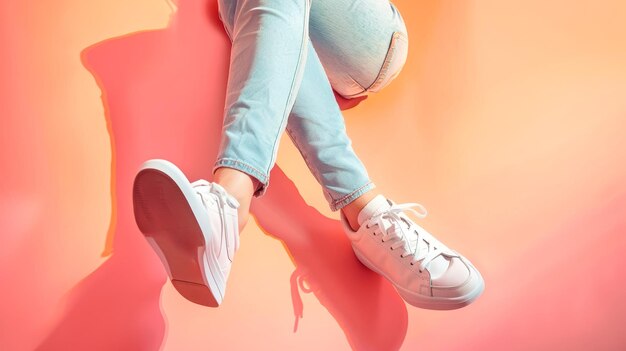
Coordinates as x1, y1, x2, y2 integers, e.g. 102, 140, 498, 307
133, 160, 225, 307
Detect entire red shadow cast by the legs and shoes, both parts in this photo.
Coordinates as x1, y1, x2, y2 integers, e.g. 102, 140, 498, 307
38, 0, 407, 350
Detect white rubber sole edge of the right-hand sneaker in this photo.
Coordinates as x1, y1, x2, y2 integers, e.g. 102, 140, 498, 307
354, 249, 485, 310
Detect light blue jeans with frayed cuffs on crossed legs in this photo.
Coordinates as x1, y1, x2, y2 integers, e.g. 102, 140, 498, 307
213, 0, 408, 211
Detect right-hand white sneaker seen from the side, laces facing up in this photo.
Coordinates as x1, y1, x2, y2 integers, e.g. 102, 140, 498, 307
341, 195, 485, 310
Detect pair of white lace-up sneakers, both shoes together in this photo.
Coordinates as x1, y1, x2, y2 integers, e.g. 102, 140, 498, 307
133, 159, 484, 310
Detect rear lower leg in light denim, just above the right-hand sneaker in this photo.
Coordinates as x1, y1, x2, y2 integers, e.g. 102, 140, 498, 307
286, 38, 375, 226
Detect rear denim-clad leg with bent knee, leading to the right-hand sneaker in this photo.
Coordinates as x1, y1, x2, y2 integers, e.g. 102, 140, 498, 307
287, 0, 408, 229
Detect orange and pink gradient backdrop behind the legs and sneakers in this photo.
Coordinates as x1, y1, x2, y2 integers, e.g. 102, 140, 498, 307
0, 0, 626, 350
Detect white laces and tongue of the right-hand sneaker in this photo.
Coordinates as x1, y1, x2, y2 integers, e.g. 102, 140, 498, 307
366, 203, 454, 272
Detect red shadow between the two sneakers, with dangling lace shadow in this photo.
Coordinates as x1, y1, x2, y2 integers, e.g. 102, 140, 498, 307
251, 167, 408, 350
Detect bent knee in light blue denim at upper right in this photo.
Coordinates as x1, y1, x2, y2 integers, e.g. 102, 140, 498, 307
309, 0, 409, 98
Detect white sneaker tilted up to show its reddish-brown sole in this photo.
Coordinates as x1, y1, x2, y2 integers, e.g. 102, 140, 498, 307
133, 159, 239, 307
